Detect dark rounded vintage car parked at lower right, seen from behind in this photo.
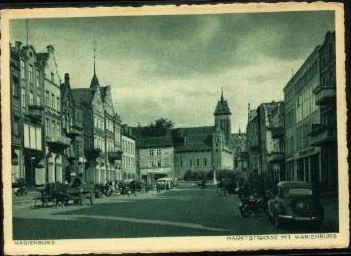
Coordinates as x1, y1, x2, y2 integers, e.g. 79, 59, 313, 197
267, 181, 324, 227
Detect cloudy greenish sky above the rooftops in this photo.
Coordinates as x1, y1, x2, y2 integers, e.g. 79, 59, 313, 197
10, 11, 334, 132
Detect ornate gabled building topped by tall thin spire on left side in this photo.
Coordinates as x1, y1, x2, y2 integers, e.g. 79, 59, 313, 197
72, 58, 122, 184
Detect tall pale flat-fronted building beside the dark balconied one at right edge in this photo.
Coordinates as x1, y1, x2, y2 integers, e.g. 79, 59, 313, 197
284, 46, 321, 183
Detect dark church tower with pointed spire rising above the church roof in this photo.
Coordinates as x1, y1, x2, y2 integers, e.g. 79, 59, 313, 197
213, 90, 232, 143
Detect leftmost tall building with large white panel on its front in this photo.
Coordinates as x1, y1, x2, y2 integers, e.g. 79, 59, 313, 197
9, 42, 45, 185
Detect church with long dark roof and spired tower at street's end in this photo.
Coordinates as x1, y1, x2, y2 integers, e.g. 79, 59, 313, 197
173, 92, 235, 179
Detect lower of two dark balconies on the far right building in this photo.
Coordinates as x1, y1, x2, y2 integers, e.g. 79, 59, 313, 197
310, 124, 336, 147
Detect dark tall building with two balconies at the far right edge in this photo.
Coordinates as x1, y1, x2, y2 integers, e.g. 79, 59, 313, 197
310, 32, 338, 192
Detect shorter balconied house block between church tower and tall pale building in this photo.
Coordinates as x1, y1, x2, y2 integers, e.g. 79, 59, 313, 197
246, 101, 285, 187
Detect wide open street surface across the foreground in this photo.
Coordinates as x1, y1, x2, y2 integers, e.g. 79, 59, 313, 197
13, 187, 337, 240
